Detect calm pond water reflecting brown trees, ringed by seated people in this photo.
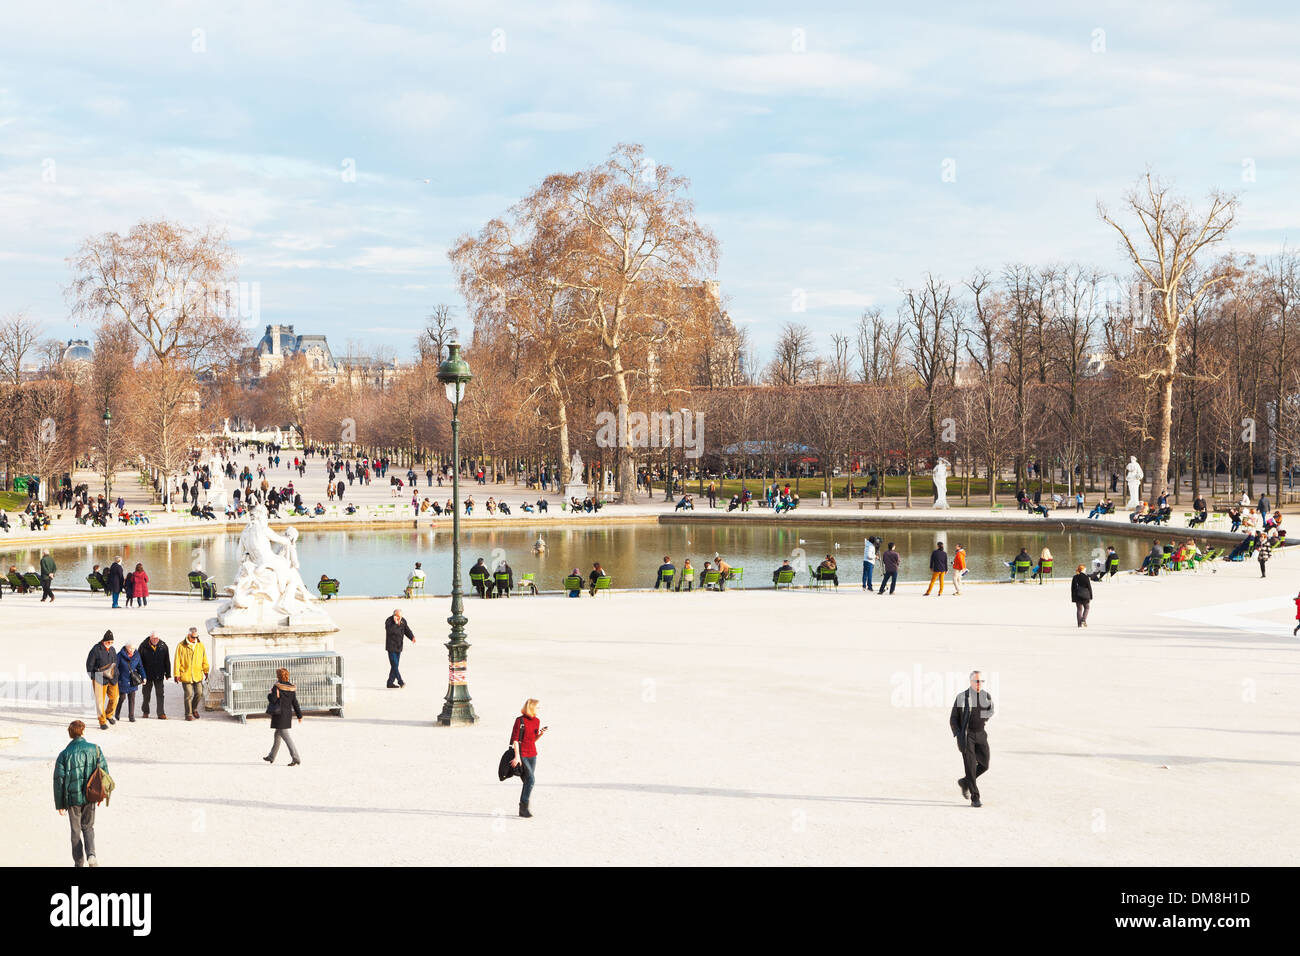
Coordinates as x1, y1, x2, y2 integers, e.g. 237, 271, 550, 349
0, 522, 1169, 596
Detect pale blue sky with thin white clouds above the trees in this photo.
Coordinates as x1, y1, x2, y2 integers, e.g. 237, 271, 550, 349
0, 0, 1300, 359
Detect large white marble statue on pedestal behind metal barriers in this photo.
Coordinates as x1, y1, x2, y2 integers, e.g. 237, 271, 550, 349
217, 505, 333, 627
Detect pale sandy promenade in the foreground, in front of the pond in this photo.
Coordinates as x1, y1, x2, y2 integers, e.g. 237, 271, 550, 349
0, 551, 1300, 866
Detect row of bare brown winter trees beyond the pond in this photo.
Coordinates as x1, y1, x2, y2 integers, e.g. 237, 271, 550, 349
0, 151, 1300, 509
